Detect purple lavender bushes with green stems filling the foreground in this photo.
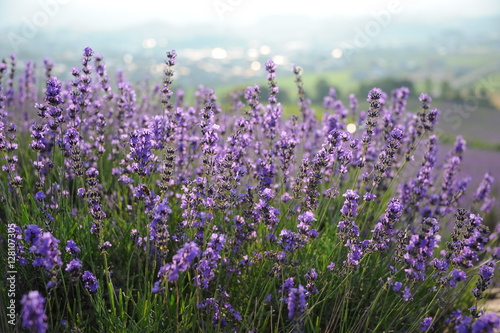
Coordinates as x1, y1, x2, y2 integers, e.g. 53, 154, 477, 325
0, 48, 500, 332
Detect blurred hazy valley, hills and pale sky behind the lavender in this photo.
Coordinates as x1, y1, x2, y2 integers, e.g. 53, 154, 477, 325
0, 0, 500, 210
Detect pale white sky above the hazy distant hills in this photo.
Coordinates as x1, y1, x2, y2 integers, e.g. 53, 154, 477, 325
0, 0, 500, 30
